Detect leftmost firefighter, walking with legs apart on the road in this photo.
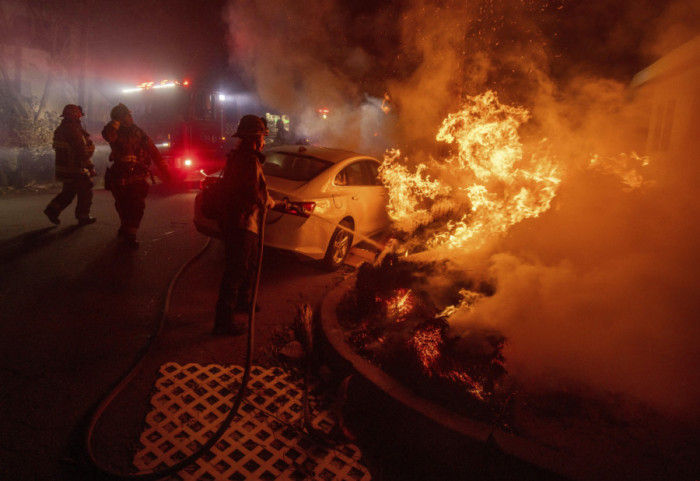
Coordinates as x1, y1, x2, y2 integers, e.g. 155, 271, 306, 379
44, 104, 97, 225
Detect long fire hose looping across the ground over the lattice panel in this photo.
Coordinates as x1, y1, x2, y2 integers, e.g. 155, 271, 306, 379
85, 206, 267, 480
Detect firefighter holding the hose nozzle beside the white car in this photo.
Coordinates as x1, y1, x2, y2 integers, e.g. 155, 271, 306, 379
213, 115, 275, 335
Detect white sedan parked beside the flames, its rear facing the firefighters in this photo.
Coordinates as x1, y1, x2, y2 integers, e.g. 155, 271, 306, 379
194, 146, 390, 269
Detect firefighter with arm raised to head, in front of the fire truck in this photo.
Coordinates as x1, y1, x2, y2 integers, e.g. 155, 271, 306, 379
102, 103, 170, 249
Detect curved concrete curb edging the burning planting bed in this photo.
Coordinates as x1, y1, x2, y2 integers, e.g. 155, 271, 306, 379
320, 279, 595, 480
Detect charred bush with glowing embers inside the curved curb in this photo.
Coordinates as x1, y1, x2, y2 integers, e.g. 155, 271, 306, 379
338, 254, 507, 422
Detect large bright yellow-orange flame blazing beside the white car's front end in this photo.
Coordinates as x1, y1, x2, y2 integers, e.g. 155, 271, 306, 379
380, 91, 560, 253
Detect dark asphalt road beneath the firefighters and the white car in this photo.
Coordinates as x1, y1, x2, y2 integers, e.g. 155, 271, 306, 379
0, 185, 352, 480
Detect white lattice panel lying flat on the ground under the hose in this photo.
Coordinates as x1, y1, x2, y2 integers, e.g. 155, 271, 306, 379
134, 363, 371, 481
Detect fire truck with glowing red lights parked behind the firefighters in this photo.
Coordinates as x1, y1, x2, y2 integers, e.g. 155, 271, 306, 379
122, 80, 226, 182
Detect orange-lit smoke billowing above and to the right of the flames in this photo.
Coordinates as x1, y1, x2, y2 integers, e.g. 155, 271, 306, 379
226, 0, 700, 417
